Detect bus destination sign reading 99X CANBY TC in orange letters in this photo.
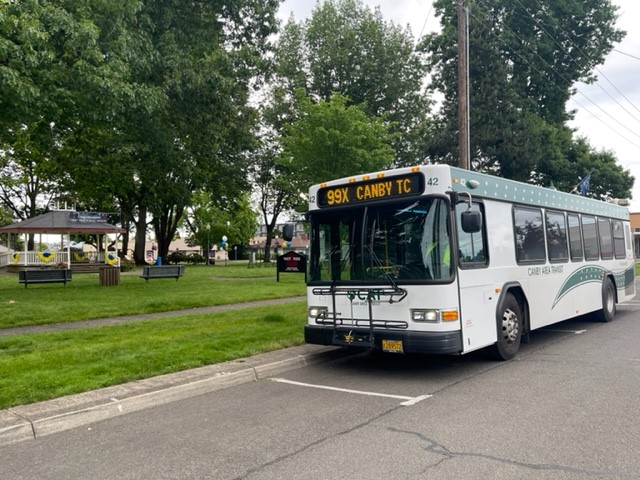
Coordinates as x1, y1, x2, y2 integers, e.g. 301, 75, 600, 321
318, 172, 424, 207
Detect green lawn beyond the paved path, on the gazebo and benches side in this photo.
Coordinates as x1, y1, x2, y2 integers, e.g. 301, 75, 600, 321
0, 263, 306, 328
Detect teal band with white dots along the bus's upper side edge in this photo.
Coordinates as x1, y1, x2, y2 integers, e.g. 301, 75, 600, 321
451, 167, 629, 220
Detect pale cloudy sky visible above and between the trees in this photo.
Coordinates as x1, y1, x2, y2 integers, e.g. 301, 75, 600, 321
279, 0, 640, 212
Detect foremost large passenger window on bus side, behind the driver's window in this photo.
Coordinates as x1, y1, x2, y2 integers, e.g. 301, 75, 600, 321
513, 207, 545, 263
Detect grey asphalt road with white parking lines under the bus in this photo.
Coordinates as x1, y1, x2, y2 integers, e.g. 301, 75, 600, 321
0, 302, 640, 480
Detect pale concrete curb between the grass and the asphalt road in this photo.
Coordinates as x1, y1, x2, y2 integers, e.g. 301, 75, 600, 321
0, 345, 353, 447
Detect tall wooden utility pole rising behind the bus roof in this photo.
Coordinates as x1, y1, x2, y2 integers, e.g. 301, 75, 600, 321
458, 0, 471, 170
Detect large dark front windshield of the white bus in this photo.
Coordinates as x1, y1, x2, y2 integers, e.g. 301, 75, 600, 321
310, 197, 453, 283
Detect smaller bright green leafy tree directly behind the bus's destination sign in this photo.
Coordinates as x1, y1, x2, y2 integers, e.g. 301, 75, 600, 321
279, 94, 394, 210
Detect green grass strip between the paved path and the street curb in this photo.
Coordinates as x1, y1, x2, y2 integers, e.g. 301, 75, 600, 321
0, 302, 306, 408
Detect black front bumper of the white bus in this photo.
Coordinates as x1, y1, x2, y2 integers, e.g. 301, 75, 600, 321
304, 325, 462, 355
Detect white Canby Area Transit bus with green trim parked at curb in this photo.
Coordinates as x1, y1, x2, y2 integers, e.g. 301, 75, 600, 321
288, 165, 635, 360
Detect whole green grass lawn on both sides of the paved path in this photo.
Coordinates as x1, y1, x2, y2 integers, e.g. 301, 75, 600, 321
0, 263, 306, 408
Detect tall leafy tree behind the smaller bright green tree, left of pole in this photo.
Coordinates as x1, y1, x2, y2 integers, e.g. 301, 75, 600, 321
275, 0, 431, 165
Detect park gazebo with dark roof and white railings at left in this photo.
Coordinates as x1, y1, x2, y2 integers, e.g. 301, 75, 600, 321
0, 210, 126, 268
